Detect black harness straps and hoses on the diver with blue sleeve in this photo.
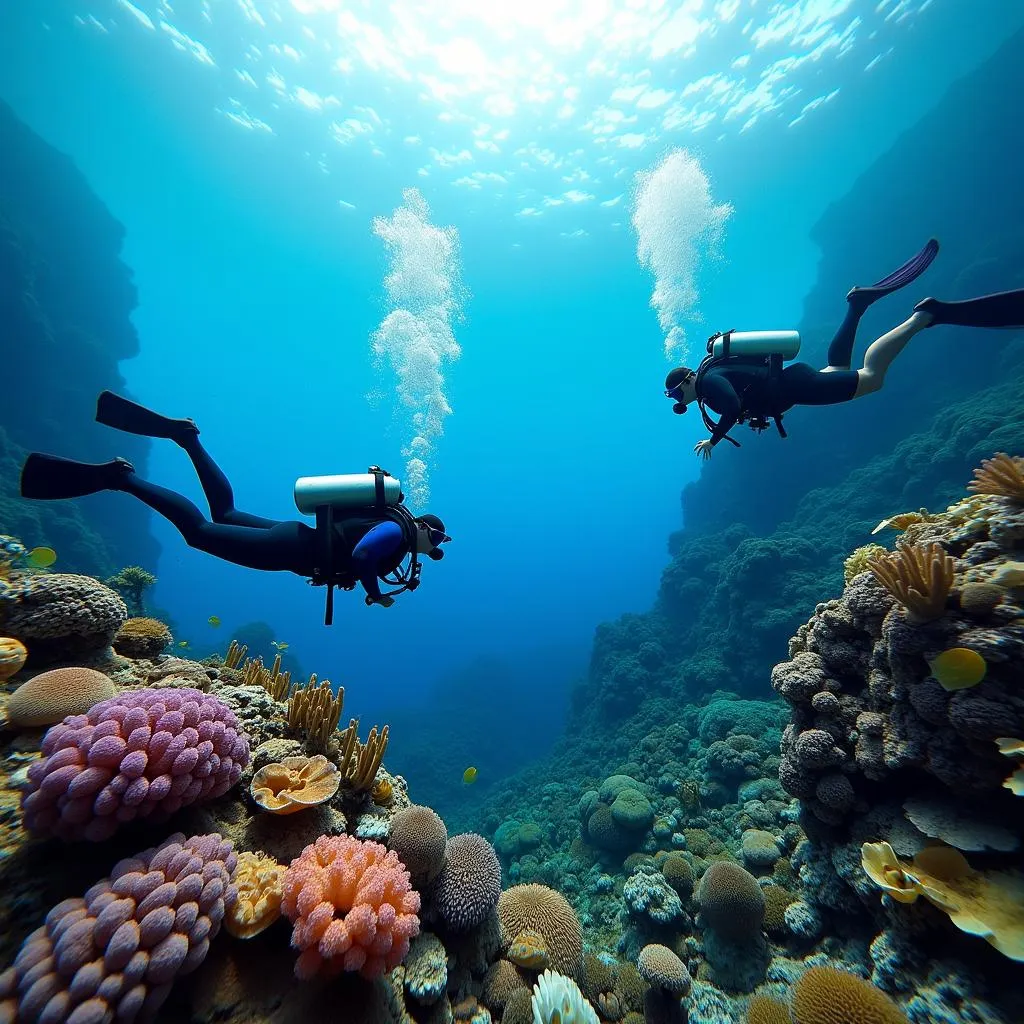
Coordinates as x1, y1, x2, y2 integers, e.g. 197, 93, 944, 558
309, 466, 423, 626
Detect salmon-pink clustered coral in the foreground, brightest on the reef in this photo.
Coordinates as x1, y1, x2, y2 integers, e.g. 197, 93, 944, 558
281, 836, 420, 978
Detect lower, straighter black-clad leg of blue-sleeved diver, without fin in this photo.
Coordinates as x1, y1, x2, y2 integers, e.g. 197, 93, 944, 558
114, 473, 314, 575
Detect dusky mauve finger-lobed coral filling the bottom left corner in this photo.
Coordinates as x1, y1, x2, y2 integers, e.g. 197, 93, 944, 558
0, 834, 237, 1024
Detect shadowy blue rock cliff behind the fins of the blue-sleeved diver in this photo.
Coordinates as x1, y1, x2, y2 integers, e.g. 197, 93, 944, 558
0, 102, 158, 575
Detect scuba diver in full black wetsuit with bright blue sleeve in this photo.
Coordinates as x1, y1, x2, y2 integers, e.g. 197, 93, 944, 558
22, 391, 452, 626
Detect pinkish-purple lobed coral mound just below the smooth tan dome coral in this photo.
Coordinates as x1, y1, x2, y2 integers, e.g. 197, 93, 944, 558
22, 688, 249, 841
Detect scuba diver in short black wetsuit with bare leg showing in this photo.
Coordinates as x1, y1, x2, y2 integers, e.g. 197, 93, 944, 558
665, 239, 1024, 459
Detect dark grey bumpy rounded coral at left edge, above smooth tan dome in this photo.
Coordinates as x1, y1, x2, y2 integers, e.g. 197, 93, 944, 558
0, 572, 128, 664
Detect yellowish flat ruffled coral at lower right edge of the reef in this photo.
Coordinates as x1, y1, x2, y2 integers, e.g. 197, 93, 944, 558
861, 843, 1024, 962
